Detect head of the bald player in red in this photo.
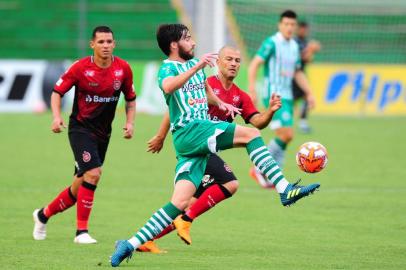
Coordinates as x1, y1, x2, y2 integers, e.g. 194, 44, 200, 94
217, 48, 241, 80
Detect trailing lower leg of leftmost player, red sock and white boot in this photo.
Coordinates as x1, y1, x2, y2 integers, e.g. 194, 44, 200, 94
32, 186, 76, 240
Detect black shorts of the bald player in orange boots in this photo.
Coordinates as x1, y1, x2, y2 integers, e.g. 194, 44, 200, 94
193, 154, 237, 198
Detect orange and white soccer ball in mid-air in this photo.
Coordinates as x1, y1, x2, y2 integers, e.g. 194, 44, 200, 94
296, 142, 327, 173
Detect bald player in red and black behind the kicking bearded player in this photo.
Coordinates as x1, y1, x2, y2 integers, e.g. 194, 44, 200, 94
139, 46, 282, 253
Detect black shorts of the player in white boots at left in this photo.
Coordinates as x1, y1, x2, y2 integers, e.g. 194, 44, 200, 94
69, 131, 109, 177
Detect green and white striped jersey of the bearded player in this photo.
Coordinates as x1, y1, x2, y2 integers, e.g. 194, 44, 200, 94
158, 59, 209, 132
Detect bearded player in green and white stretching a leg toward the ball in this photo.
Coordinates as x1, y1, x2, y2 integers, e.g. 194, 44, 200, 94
111, 24, 320, 267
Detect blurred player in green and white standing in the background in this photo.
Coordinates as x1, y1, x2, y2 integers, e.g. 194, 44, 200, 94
248, 10, 314, 171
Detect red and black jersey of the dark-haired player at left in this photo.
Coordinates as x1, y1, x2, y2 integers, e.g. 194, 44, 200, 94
54, 56, 135, 139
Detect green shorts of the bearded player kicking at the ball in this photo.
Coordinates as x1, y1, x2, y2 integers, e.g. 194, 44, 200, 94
173, 120, 236, 188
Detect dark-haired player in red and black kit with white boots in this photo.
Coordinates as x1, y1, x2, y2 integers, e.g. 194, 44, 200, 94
33, 26, 135, 244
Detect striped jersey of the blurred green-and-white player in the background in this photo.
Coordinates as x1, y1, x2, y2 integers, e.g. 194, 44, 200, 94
256, 32, 300, 101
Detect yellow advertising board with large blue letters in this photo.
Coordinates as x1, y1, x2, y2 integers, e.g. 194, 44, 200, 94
307, 64, 406, 115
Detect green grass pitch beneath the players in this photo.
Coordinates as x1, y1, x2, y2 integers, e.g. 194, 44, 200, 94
0, 112, 406, 270
